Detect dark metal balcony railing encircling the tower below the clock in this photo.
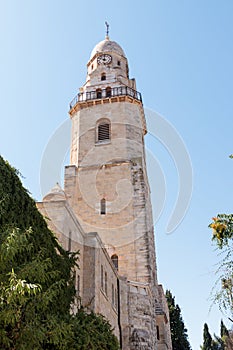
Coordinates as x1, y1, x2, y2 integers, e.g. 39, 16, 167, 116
70, 86, 142, 109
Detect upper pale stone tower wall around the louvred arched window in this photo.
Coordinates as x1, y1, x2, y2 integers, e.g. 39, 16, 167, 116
70, 102, 145, 167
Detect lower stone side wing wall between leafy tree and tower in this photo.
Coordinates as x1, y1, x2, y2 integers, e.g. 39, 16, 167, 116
37, 200, 119, 338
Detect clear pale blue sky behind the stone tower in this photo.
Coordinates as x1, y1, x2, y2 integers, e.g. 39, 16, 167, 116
0, 0, 233, 350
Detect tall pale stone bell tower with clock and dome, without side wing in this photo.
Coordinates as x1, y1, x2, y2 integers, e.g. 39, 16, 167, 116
64, 33, 171, 350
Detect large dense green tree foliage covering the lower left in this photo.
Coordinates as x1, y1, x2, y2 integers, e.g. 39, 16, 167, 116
0, 157, 119, 350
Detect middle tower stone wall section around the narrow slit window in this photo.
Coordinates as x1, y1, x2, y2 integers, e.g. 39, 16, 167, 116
65, 162, 156, 282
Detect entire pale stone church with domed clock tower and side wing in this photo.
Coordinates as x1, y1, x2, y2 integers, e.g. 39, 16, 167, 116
37, 28, 172, 350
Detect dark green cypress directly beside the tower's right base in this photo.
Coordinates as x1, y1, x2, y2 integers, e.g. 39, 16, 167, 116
166, 290, 191, 350
